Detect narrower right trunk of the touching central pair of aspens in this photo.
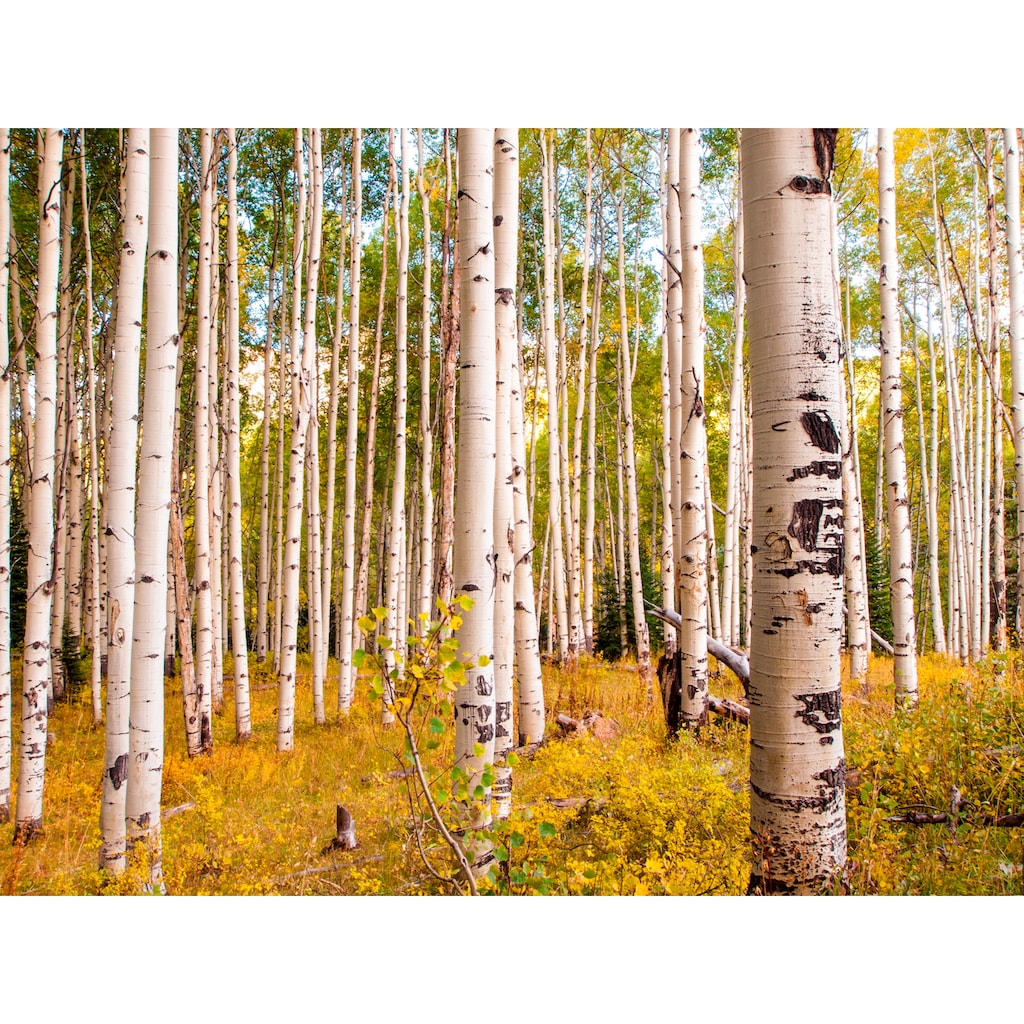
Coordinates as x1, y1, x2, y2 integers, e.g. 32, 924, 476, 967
493, 128, 519, 818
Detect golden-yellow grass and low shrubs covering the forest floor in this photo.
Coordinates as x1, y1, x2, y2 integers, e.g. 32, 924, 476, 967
0, 652, 1024, 895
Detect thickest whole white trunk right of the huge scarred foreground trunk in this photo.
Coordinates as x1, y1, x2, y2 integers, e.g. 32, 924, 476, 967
878, 128, 918, 707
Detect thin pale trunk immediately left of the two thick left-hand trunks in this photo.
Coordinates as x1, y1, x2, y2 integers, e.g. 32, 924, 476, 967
80, 136, 103, 725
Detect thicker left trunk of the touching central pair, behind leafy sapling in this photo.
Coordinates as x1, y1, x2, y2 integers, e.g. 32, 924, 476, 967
453, 128, 497, 824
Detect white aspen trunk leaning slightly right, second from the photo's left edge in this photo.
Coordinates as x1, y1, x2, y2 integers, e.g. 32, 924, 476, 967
14, 128, 63, 845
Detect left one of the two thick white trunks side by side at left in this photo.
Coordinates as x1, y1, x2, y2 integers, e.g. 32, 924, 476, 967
99, 128, 149, 873
